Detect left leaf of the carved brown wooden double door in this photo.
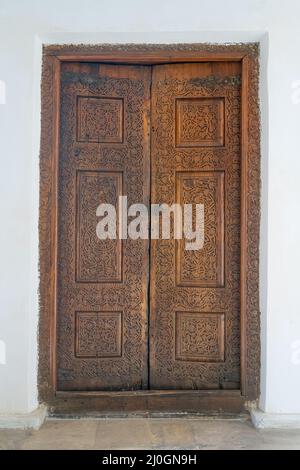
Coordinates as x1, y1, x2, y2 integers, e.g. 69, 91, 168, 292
56, 63, 151, 391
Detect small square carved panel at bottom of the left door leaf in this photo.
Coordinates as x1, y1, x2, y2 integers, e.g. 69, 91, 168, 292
75, 312, 122, 358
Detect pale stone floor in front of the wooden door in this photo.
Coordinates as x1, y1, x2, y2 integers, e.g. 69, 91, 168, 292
0, 417, 300, 450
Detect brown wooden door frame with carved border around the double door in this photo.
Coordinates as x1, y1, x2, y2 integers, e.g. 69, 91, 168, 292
38, 43, 260, 414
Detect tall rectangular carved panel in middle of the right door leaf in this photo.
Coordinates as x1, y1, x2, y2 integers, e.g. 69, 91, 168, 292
176, 171, 224, 287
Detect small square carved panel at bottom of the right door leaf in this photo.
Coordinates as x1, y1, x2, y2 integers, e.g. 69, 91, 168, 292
175, 312, 225, 362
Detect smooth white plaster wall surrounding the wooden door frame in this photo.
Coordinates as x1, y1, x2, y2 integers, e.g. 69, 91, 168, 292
0, 0, 300, 413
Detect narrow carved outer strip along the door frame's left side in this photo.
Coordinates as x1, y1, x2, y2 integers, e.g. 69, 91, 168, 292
38, 56, 55, 402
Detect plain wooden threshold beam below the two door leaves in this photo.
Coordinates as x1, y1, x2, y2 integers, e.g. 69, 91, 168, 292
48, 390, 246, 416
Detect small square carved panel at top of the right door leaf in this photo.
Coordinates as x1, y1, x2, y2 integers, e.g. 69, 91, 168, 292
176, 98, 224, 147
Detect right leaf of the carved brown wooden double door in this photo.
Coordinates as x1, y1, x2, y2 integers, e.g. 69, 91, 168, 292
150, 62, 241, 390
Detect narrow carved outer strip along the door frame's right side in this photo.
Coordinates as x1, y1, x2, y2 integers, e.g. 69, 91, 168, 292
244, 54, 260, 400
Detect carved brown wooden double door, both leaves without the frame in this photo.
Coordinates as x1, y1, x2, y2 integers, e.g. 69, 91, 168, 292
56, 62, 241, 391
